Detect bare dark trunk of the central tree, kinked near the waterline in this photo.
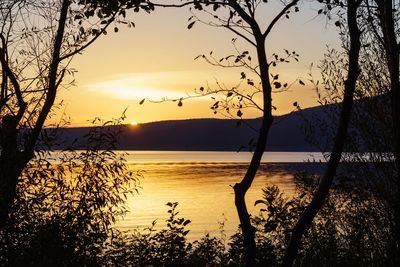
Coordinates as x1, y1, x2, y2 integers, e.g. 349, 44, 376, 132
233, 27, 273, 266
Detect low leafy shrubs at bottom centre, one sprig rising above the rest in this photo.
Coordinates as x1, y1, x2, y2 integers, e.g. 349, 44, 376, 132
105, 202, 227, 266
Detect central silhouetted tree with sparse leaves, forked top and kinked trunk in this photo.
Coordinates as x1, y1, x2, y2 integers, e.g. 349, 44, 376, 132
152, 0, 303, 266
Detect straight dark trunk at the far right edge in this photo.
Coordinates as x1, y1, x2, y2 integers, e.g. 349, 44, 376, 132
376, 0, 400, 263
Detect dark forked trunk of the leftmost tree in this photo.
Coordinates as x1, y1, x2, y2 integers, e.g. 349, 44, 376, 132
0, 0, 70, 227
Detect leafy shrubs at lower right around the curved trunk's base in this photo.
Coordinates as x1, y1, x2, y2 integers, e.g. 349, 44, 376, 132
228, 173, 395, 266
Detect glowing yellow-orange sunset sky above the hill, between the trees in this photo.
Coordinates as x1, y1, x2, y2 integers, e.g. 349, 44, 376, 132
51, 1, 339, 126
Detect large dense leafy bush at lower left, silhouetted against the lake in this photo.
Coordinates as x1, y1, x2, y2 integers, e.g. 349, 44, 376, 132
0, 120, 140, 266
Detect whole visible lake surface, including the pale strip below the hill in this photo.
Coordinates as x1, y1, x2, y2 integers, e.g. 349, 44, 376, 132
116, 151, 322, 240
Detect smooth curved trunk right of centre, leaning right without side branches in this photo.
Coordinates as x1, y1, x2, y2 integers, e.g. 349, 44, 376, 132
283, 0, 360, 266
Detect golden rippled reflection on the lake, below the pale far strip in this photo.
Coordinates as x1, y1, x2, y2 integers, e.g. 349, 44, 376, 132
117, 162, 324, 240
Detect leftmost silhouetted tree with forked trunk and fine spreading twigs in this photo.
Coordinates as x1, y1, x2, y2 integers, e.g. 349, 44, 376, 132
0, 0, 153, 225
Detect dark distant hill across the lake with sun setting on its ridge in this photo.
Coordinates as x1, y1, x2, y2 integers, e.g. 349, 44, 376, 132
49, 107, 323, 151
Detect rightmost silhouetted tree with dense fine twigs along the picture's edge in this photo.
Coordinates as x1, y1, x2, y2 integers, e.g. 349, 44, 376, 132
284, 1, 400, 265
